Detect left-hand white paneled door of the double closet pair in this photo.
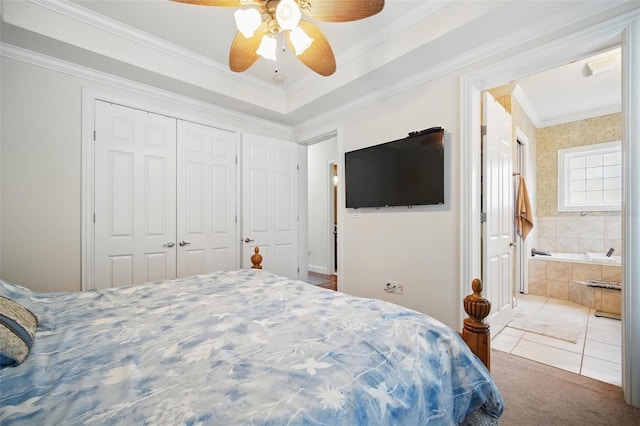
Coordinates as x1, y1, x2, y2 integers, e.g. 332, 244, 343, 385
94, 101, 176, 288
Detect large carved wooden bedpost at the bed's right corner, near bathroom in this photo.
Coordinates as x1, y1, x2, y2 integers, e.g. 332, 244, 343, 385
462, 278, 491, 369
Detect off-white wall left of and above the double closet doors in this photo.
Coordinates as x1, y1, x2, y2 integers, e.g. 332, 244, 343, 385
0, 57, 290, 291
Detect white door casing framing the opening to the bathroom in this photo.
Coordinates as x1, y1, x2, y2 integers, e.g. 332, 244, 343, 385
460, 25, 640, 400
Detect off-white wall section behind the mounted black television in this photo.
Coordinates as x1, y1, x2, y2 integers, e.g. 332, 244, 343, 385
340, 75, 460, 328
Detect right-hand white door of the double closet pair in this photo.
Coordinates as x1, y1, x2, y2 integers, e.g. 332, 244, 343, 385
177, 120, 239, 276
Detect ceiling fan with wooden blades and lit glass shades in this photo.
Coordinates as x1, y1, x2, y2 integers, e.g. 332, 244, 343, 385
172, 0, 384, 76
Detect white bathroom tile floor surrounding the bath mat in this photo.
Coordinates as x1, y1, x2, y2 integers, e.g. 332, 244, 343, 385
491, 294, 622, 386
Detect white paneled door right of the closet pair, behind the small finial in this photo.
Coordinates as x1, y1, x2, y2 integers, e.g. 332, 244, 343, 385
242, 134, 298, 279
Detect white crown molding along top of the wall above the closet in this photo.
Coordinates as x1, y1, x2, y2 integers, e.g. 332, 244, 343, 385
0, 42, 291, 134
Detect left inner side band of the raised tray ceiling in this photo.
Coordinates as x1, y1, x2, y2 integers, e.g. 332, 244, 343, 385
2, 0, 286, 114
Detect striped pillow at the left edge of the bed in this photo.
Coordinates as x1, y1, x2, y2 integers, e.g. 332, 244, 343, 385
0, 296, 38, 367
